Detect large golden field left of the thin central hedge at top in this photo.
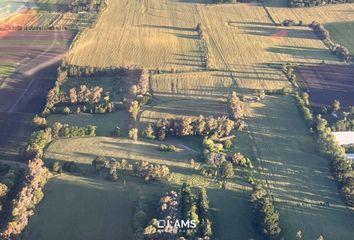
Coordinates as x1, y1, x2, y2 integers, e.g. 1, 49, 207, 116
70, 0, 201, 70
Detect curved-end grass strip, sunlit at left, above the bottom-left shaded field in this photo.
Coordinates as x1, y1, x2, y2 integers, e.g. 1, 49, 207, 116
45, 137, 199, 173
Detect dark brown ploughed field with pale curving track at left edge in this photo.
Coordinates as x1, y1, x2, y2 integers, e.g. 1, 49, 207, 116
0, 31, 74, 158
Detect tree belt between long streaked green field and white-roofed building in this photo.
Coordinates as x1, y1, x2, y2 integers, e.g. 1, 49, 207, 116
315, 115, 354, 207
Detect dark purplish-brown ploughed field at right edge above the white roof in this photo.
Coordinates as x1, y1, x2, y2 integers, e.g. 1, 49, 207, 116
296, 65, 354, 112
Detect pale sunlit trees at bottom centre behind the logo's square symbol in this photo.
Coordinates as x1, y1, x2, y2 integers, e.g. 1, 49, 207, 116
143, 191, 181, 240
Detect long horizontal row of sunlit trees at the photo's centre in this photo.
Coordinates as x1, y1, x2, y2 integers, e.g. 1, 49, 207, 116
144, 115, 235, 140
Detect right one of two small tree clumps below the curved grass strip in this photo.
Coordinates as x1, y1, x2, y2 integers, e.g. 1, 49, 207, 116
133, 161, 170, 182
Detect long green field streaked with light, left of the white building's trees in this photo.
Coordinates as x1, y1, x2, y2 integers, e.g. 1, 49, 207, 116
248, 96, 354, 239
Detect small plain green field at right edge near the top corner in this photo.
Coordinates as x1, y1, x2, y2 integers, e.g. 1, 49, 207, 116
325, 22, 354, 55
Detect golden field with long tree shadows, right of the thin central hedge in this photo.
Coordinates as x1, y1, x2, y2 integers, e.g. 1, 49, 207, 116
196, 4, 339, 89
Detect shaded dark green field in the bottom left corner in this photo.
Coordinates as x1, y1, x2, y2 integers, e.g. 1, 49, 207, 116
21, 175, 166, 240
